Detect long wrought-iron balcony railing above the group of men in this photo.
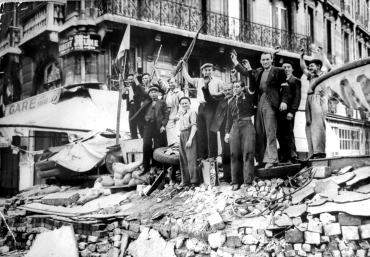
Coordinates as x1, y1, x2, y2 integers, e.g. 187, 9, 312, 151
98, 0, 310, 53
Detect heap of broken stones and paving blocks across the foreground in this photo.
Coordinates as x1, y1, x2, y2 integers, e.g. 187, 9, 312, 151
0, 167, 370, 257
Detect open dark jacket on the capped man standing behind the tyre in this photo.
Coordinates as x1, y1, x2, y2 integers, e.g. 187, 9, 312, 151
130, 99, 169, 130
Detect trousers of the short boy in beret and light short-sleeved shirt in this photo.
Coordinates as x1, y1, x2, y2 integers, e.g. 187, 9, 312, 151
179, 131, 199, 184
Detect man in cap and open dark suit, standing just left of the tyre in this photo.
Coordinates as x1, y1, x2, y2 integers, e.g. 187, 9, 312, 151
130, 86, 169, 174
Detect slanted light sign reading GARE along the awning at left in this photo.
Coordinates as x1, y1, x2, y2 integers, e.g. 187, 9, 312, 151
5, 88, 62, 116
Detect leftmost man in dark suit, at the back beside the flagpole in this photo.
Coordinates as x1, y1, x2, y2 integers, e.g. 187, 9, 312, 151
122, 74, 144, 139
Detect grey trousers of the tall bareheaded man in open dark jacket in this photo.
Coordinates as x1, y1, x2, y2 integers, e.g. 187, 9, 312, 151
256, 93, 279, 163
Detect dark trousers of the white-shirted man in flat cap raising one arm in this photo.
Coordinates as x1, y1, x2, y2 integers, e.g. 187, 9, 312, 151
197, 104, 217, 159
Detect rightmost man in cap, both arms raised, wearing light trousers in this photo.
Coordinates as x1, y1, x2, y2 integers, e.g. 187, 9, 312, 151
300, 48, 331, 159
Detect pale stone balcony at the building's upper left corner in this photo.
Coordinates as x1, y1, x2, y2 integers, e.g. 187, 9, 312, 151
20, 2, 65, 45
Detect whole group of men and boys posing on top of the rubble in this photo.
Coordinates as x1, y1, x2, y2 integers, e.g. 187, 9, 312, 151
122, 46, 330, 190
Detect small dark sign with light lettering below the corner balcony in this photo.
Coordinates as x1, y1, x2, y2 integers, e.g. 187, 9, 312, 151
59, 34, 100, 56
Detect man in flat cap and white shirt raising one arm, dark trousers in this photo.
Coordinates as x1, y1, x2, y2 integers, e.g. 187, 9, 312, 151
182, 61, 224, 159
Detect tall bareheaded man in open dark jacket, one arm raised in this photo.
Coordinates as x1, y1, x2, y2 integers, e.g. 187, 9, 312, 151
231, 53, 291, 169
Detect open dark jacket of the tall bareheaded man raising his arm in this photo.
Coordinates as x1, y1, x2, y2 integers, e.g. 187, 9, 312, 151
235, 63, 291, 109
